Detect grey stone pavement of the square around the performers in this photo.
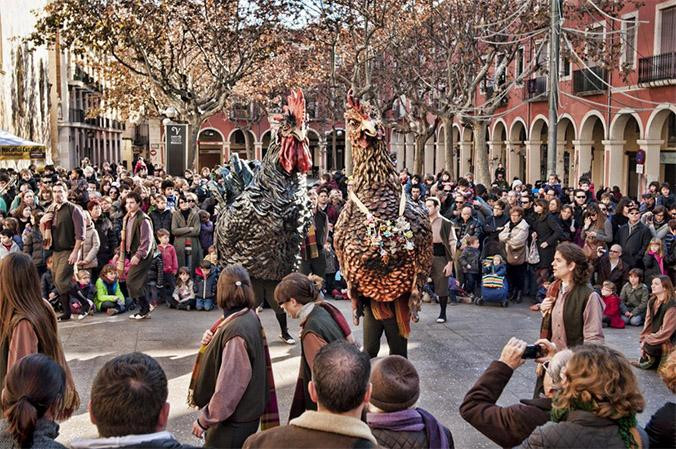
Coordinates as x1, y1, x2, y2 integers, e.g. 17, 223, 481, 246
59, 301, 673, 448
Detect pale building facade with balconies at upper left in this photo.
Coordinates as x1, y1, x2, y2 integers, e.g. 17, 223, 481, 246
0, 0, 125, 168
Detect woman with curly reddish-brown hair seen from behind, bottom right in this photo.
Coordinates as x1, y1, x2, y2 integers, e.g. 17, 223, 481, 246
522, 344, 648, 449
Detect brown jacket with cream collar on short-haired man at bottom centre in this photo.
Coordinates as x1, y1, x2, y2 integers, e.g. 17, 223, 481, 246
243, 411, 378, 449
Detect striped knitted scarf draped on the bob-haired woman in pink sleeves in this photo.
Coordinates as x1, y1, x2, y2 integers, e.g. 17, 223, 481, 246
188, 312, 279, 430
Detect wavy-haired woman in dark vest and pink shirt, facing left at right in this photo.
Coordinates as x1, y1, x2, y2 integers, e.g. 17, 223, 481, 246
540, 242, 604, 350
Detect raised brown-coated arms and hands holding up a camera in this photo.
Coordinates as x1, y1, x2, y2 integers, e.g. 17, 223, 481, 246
460, 337, 573, 447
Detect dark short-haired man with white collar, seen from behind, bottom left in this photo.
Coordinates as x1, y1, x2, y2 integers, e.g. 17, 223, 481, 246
71, 352, 198, 449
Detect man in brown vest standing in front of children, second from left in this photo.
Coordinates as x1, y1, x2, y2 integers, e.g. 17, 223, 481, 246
122, 192, 155, 320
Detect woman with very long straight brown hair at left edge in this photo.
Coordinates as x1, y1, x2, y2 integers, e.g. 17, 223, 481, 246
0, 253, 80, 421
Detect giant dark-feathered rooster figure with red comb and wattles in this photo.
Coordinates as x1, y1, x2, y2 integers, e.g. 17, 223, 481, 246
216, 89, 312, 342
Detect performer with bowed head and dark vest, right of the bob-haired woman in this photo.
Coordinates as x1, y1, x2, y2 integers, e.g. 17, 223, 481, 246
275, 273, 354, 420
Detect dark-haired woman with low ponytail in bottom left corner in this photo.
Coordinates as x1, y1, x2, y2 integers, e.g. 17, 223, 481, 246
0, 354, 66, 449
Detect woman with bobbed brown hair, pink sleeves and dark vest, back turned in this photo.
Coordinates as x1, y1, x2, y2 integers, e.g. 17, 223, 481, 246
188, 265, 279, 448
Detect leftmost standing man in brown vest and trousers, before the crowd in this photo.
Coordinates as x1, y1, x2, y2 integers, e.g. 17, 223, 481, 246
40, 182, 85, 321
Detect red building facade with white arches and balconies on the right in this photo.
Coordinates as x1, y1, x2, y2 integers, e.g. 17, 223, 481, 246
392, 0, 676, 196
